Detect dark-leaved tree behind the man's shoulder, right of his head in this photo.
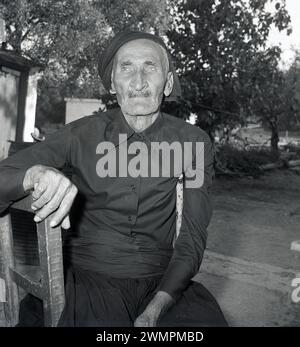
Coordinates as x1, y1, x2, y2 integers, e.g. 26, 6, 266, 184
167, 0, 290, 138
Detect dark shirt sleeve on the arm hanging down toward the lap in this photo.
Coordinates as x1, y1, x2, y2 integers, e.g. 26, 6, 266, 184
157, 134, 214, 301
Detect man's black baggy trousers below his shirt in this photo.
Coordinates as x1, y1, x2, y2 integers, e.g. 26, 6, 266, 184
18, 269, 227, 327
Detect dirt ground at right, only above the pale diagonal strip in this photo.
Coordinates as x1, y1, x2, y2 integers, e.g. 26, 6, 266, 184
207, 170, 300, 271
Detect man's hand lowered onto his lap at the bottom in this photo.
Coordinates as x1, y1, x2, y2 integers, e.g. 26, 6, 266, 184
134, 291, 174, 327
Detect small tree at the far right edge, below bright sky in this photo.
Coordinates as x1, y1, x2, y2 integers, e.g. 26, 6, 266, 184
239, 47, 300, 150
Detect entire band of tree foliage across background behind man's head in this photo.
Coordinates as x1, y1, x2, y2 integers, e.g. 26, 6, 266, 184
0, 0, 300, 138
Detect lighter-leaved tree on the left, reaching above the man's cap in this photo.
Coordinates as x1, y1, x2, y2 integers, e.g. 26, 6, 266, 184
0, 0, 171, 122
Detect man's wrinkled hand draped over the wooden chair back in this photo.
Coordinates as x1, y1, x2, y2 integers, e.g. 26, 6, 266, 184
23, 165, 78, 229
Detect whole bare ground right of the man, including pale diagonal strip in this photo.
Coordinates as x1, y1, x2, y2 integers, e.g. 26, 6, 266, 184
197, 170, 300, 326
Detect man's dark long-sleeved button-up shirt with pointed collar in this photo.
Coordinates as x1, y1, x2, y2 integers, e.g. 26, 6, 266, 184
0, 109, 213, 299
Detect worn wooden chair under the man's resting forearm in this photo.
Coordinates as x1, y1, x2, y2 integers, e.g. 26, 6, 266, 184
0, 196, 64, 327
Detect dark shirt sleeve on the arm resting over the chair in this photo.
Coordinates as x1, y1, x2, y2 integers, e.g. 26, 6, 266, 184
0, 125, 71, 213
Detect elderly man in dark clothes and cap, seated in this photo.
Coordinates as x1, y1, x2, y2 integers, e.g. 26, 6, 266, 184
0, 32, 226, 326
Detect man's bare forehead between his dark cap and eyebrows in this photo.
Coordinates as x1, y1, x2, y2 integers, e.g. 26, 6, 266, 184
116, 39, 164, 62
